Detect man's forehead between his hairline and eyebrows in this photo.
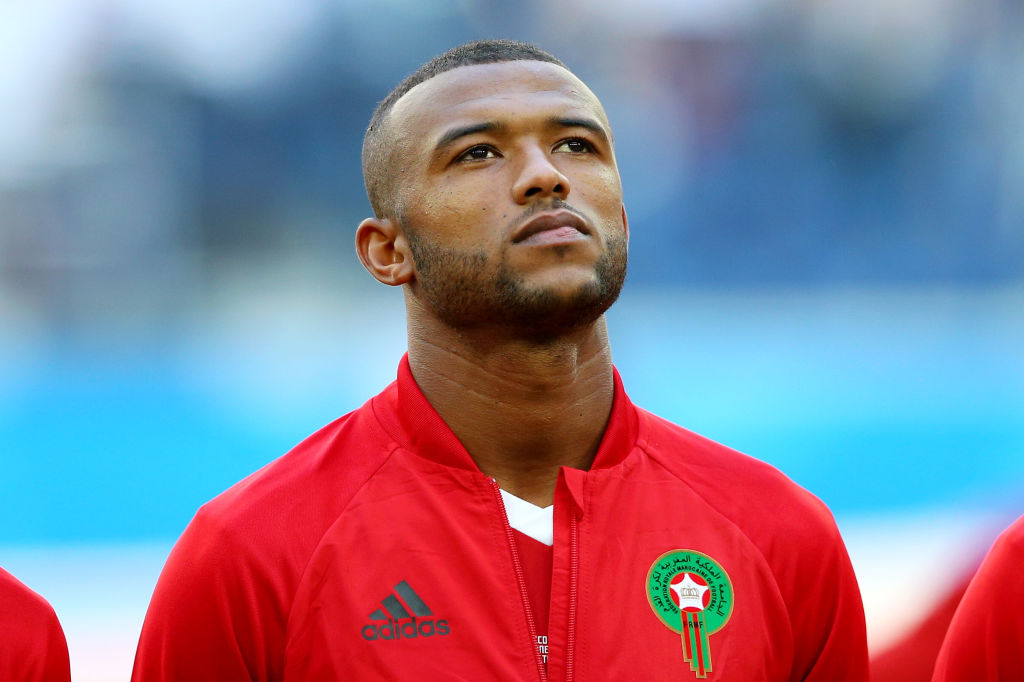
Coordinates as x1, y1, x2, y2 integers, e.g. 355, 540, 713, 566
391, 59, 608, 133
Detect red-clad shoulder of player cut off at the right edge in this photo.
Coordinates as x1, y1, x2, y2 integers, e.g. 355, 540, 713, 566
932, 516, 1024, 682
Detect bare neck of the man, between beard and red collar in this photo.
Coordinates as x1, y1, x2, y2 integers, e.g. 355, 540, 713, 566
409, 316, 614, 506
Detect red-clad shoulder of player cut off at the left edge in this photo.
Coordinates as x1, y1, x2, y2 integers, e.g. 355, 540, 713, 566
0, 568, 71, 682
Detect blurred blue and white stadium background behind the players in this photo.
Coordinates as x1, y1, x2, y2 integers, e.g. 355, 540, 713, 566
0, 0, 1024, 682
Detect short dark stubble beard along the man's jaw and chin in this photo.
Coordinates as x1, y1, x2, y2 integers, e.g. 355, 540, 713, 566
406, 226, 627, 341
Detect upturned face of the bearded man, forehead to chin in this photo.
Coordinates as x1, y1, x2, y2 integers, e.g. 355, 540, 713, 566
389, 61, 627, 335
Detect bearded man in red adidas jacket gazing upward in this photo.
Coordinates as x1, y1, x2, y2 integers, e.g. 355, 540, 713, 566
134, 41, 866, 682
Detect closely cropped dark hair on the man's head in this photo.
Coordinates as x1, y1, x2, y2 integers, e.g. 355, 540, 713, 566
362, 40, 568, 218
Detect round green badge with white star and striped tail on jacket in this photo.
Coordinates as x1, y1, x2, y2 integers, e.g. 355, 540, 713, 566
646, 550, 733, 678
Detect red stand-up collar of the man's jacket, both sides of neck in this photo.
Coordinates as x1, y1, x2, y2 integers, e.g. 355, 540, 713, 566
373, 353, 638, 471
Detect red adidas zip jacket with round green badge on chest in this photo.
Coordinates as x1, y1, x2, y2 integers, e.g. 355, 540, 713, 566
133, 359, 867, 682
